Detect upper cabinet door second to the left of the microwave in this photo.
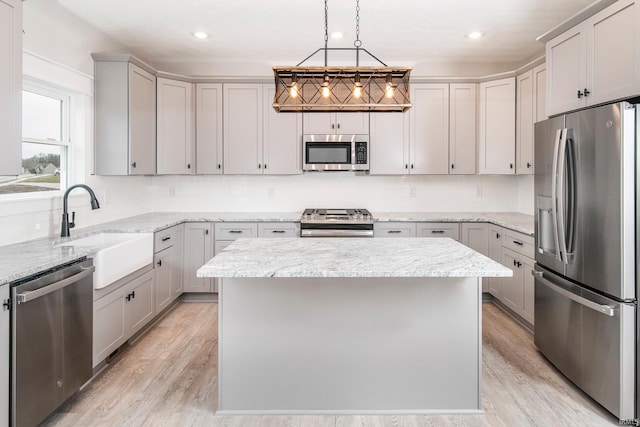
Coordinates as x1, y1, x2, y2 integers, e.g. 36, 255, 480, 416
223, 83, 263, 175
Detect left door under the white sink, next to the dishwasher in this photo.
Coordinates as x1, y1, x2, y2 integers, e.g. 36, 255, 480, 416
93, 285, 128, 368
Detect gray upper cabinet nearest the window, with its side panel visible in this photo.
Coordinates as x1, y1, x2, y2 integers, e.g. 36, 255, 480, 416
92, 54, 156, 175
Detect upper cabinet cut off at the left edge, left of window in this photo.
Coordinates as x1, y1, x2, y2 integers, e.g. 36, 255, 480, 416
0, 0, 22, 176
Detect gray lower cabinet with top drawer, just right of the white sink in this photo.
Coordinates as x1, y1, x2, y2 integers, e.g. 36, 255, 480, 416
153, 224, 184, 313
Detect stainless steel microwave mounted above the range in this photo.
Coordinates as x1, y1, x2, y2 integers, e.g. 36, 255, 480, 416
302, 135, 369, 171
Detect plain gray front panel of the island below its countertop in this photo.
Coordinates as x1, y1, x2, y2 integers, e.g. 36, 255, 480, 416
218, 277, 482, 414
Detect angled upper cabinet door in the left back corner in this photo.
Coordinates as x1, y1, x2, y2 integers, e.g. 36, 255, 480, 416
157, 77, 195, 175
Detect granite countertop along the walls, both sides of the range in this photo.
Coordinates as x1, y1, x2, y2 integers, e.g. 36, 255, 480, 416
0, 211, 534, 284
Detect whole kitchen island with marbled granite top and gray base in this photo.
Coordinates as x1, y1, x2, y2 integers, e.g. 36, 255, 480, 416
198, 238, 512, 414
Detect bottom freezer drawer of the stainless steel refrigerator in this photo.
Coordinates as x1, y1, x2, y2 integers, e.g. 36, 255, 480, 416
534, 266, 636, 420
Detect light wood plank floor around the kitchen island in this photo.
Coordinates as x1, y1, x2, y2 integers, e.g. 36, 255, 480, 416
45, 303, 618, 427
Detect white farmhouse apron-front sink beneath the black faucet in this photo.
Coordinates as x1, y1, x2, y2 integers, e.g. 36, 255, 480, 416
59, 233, 153, 289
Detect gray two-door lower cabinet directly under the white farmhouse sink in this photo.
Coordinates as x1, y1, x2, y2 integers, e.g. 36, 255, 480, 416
93, 269, 155, 367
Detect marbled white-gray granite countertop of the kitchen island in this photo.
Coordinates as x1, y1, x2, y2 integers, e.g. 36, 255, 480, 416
197, 237, 513, 278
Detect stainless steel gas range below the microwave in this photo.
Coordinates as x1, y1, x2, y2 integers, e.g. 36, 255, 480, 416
300, 209, 373, 237
